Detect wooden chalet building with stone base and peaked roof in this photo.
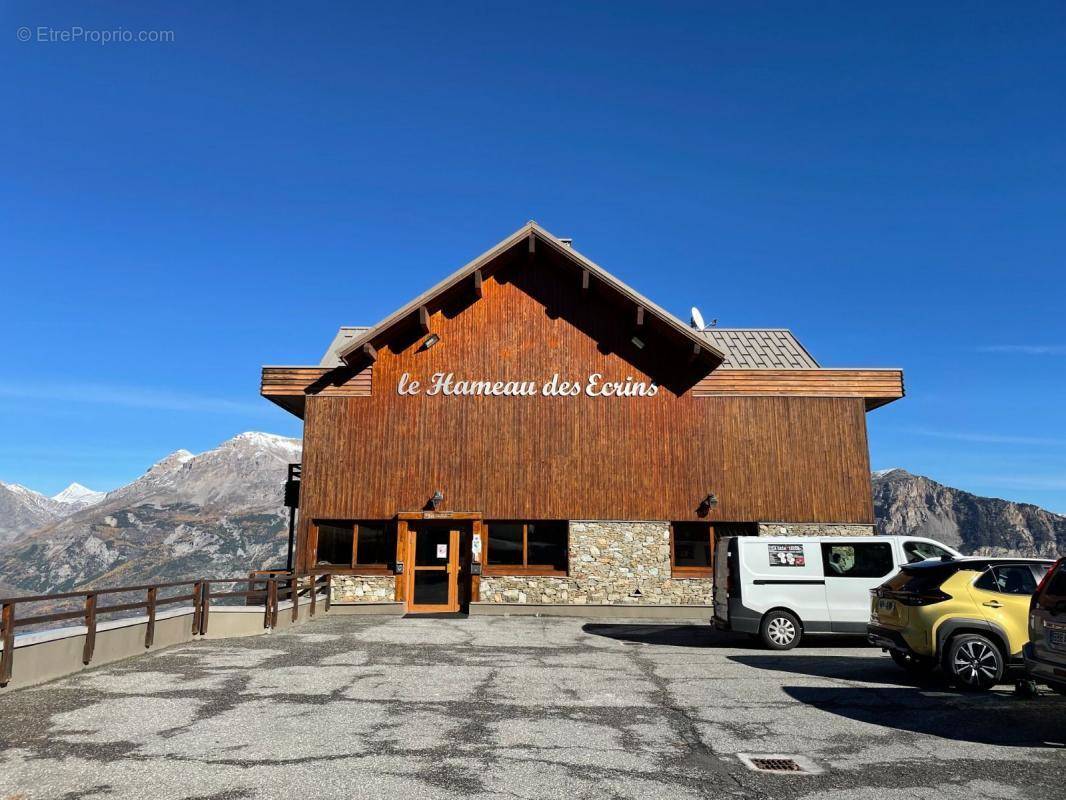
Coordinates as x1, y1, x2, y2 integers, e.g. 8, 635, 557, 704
262, 223, 903, 617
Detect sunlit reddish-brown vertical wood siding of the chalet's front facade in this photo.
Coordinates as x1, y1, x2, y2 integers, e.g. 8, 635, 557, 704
287, 253, 877, 558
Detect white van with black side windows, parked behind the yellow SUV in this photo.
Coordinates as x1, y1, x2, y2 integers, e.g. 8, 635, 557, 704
714, 537, 962, 650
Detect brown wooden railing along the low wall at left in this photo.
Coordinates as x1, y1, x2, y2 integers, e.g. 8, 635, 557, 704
0, 570, 333, 688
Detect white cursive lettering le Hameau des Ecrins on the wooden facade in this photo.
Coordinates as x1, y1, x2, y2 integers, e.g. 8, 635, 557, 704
397, 372, 659, 397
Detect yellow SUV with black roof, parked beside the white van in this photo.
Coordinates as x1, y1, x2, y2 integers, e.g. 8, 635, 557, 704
867, 558, 1054, 690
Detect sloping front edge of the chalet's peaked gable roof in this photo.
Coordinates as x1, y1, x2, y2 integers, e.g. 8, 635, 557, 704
338, 221, 726, 368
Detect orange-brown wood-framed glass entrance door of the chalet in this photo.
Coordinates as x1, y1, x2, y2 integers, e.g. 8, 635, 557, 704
407, 525, 459, 613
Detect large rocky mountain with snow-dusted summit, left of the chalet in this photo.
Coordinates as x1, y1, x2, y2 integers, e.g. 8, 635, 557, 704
0, 432, 301, 593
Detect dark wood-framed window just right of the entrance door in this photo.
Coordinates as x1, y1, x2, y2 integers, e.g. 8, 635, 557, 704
485, 522, 569, 575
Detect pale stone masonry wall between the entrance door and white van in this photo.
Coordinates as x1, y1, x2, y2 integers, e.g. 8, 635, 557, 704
481, 522, 712, 605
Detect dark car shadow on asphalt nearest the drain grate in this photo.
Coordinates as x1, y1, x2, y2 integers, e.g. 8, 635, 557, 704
781, 686, 1066, 750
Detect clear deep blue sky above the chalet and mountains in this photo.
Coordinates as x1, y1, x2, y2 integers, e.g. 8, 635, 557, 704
0, 2, 1066, 512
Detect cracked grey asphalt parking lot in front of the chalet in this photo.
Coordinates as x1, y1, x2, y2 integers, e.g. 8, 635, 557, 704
0, 615, 1066, 800
